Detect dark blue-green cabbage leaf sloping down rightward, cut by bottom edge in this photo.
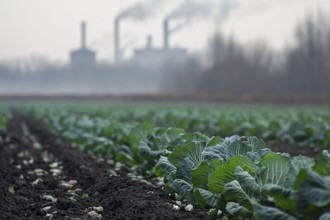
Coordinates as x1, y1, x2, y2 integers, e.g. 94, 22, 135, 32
252, 202, 298, 220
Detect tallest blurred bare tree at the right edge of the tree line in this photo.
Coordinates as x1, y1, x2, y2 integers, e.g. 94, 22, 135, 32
287, 11, 330, 96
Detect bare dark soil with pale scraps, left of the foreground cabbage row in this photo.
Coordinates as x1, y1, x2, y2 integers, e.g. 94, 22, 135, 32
0, 115, 210, 220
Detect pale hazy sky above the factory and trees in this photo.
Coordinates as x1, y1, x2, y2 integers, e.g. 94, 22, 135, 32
0, 0, 330, 62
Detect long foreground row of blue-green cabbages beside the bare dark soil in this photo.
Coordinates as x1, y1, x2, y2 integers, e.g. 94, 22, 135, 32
28, 108, 330, 220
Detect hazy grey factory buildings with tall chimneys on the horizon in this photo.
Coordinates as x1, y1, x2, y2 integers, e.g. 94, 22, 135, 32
70, 18, 188, 69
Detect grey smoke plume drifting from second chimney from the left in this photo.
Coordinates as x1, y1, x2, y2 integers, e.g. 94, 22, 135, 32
117, 0, 164, 20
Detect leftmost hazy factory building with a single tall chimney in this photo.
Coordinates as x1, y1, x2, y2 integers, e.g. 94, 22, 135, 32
70, 22, 96, 68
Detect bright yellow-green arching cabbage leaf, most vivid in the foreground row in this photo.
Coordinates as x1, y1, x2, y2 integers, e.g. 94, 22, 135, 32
208, 155, 256, 193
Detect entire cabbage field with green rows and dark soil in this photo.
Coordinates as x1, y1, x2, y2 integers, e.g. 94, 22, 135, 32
0, 103, 330, 220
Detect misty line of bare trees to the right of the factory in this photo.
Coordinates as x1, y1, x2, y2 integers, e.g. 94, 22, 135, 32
174, 12, 330, 98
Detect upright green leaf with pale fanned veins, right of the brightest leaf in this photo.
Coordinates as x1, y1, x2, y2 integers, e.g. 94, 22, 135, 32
255, 153, 291, 186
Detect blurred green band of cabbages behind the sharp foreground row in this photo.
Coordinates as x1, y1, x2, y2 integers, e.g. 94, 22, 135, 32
29, 104, 330, 148
